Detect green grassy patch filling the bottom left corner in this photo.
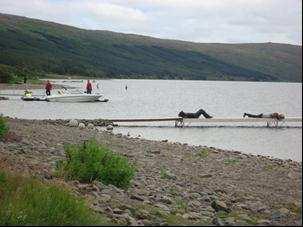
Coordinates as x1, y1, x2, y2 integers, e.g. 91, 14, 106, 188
0, 170, 106, 225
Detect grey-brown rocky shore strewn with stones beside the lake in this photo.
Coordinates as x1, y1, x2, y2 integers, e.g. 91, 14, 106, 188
0, 119, 302, 225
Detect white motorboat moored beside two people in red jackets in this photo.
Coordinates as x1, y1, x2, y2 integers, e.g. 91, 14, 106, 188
45, 89, 102, 102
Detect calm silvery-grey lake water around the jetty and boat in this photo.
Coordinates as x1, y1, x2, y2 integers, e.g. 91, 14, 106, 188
0, 80, 302, 161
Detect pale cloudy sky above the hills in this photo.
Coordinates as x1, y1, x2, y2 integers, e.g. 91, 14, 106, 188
0, 0, 302, 45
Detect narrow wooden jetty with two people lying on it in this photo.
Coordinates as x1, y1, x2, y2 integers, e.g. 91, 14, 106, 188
103, 117, 302, 127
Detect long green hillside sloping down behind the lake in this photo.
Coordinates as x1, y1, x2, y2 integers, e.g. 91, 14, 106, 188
0, 14, 302, 82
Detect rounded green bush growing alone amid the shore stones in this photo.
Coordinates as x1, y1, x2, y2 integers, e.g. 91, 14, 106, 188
57, 140, 135, 188
